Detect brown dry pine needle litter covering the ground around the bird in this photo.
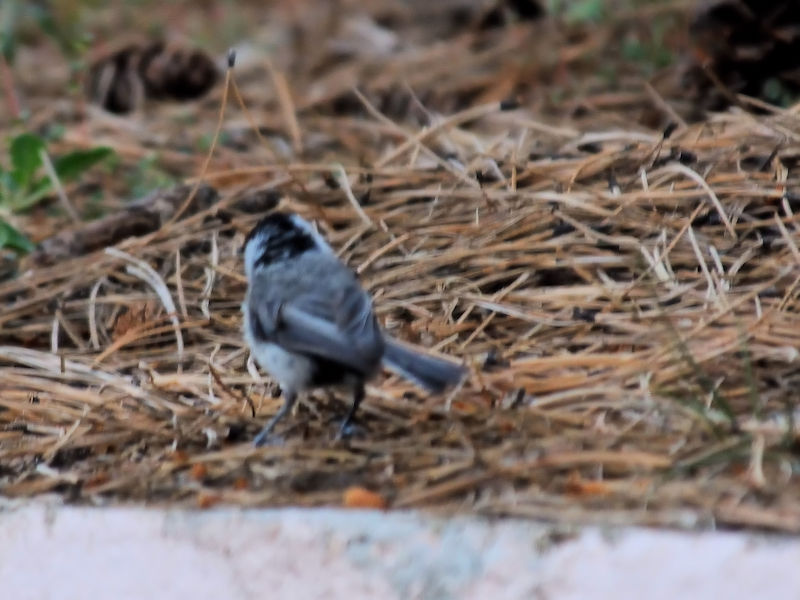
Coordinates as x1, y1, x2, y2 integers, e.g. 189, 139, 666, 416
0, 1, 800, 532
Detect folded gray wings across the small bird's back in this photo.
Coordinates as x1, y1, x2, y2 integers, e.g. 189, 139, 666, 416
251, 284, 383, 372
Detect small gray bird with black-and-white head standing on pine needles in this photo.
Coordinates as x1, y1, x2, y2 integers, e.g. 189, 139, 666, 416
242, 212, 466, 446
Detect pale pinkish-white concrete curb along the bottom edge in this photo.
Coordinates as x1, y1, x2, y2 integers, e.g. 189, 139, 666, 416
0, 503, 800, 600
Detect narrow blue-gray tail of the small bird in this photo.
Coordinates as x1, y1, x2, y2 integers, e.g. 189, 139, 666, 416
383, 336, 467, 393
